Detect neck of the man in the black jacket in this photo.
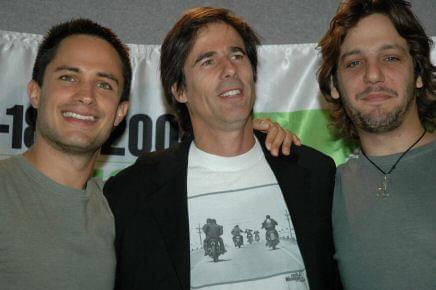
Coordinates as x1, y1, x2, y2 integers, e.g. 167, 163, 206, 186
193, 119, 255, 156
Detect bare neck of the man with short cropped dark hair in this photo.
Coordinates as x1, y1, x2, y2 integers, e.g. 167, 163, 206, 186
23, 139, 99, 189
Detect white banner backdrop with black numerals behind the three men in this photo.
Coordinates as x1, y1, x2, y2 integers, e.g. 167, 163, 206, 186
0, 31, 436, 179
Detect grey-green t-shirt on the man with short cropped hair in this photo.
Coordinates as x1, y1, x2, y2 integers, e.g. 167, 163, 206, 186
0, 155, 116, 290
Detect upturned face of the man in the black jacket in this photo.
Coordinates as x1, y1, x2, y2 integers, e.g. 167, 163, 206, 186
173, 22, 255, 134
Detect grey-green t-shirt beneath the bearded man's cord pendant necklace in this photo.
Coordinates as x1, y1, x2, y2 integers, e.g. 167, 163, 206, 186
333, 142, 436, 290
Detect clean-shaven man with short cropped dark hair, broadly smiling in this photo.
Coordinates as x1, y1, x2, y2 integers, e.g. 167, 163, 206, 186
0, 19, 132, 290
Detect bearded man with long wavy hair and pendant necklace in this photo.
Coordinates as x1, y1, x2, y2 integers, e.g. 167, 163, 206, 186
318, 0, 436, 290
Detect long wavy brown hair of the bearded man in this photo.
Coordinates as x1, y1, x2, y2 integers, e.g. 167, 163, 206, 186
318, 0, 436, 141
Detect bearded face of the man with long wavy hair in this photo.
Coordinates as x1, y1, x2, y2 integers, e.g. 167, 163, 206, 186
332, 14, 422, 133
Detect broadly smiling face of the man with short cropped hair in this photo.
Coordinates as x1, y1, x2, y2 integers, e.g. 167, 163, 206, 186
28, 35, 128, 154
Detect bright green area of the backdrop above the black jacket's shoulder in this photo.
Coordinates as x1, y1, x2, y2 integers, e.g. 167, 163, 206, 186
255, 109, 354, 165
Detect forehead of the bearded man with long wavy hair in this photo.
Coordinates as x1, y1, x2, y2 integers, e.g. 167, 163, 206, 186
341, 13, 408, 55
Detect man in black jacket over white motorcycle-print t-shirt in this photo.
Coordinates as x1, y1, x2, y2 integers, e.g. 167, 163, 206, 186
105, 7, 339, 290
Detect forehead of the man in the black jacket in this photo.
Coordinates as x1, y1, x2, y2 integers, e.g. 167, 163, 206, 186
188, 21, 245, 57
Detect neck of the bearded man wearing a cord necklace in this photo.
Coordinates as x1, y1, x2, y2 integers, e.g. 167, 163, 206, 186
358, 109, 436, 156
